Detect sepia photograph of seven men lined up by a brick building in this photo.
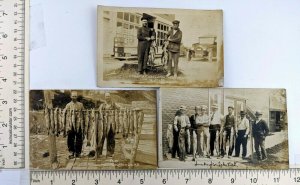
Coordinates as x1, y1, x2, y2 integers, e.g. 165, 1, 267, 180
159, 88, 289, 169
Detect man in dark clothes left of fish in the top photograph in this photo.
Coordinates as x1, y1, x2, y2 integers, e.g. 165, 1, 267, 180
137, 17, 151, 75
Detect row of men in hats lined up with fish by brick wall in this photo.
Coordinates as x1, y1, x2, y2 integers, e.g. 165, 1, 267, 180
171, 104, 269, 161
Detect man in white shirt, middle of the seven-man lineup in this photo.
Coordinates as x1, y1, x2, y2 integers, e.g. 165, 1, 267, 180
209, 104, 224, 157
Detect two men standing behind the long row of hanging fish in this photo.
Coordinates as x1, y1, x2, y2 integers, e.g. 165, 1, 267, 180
64, 91, 119, 159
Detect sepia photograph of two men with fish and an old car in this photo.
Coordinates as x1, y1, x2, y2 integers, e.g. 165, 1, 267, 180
97, 6, 224, 87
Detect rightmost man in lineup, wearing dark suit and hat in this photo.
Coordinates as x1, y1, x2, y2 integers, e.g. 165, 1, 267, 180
252, 111, 269, 161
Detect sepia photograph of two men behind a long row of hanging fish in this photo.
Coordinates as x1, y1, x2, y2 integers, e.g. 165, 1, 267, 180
29, 90, 157, 170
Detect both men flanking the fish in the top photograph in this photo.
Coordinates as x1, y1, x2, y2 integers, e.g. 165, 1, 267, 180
137, 17, 182, 77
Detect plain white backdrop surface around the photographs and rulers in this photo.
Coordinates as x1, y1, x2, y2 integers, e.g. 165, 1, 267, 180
0, 0, 300, 185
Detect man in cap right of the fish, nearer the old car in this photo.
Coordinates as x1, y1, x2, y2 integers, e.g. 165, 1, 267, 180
167, 20, 182, 77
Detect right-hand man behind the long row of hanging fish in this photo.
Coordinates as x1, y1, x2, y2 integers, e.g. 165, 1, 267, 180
96, 92, 120, 157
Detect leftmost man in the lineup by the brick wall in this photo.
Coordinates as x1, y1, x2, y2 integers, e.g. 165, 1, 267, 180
172, 105, 191, 161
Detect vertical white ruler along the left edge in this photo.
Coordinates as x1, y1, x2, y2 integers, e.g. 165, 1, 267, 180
0, 0, 26, 168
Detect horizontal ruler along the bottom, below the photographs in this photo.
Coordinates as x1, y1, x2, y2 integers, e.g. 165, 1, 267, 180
30, 169, 300, 185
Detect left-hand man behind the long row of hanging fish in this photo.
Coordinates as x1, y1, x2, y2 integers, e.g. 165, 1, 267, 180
64, 91, 83, 159
